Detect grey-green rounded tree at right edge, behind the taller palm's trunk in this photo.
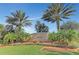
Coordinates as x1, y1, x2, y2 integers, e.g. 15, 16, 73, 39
60, 21, 79, 31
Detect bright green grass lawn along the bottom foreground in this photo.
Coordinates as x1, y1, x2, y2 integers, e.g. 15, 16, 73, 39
0, 45, 79, 55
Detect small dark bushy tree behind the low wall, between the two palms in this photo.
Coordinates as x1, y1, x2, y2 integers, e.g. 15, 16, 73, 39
35, 21, 49, 33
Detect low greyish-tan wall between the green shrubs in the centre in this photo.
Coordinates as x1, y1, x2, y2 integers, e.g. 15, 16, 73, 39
32, 32, 48, 40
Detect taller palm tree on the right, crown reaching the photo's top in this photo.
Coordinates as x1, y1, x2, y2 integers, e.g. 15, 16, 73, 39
42, 3, 75, 31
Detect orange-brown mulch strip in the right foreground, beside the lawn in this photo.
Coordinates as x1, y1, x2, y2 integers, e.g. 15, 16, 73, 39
42, 46, 79, 52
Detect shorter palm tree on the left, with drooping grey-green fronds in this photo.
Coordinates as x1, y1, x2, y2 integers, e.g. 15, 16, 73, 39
7, 10, 31, 31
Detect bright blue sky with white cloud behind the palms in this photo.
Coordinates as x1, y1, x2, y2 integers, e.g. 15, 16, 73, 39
0, 3, 79, 33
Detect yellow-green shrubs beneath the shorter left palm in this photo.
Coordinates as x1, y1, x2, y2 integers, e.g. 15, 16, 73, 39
3, 31, 30, 44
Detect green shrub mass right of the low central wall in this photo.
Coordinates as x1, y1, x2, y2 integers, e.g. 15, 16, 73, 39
49, 30, 79, 47
